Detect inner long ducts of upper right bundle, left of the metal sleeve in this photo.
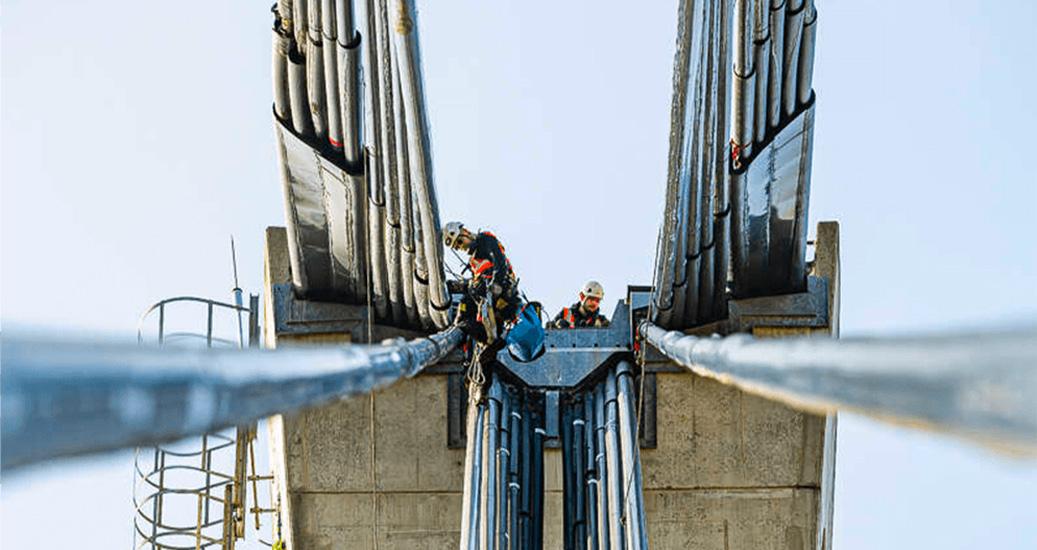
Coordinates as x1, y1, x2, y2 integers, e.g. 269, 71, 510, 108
653, 0, 730, 326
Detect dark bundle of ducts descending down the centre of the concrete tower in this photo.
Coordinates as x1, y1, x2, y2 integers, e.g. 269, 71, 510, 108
459, 361, 648, 550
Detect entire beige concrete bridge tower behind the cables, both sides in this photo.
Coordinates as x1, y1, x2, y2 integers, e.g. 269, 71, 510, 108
263, 218, 839, 550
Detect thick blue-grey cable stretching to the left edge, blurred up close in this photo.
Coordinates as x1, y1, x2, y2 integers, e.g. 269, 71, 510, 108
0, 327, 461, 471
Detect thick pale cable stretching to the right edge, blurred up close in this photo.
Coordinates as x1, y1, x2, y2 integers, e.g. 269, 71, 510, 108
638, 321, 1037, 453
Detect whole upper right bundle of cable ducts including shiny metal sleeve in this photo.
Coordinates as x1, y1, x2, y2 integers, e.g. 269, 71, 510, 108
652, 0, 817, 328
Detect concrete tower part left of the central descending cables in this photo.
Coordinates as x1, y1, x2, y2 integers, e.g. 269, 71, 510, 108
263, 227, 465, 550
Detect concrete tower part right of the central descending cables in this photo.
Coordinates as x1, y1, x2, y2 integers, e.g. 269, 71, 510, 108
641, 218, 839, 550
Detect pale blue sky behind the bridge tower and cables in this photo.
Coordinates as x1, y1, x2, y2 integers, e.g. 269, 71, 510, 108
0, 0, 1037, 550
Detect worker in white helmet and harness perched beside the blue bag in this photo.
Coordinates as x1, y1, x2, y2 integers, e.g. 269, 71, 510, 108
443, 221, 522, 345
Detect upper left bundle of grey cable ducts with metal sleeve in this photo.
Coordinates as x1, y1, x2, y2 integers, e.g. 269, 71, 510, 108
272, 0, 450, 330
